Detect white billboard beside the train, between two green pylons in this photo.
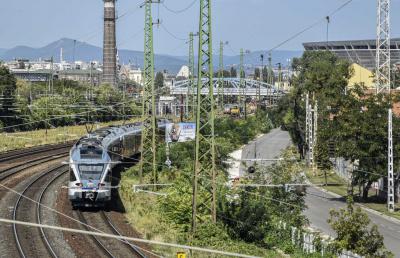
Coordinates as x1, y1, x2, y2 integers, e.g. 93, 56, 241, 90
165, 123, 196, 143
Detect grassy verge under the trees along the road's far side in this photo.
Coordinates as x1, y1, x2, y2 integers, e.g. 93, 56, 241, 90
306, 170, 400, 219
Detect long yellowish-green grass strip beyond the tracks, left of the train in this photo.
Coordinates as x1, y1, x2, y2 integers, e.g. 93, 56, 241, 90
0, 120, 134, 152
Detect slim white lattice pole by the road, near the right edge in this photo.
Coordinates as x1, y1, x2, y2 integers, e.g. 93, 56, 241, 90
387, 108, 395, 212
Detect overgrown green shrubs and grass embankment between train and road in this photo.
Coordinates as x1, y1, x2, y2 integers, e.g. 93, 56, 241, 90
121, 112, 316, 257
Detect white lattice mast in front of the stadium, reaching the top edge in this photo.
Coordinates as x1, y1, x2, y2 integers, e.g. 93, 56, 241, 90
376, 0, 391, 93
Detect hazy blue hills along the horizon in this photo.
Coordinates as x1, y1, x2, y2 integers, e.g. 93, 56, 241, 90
0, 38, 302, 73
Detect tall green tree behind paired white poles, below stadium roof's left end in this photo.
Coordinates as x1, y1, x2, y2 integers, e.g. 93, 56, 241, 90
273, 51, 352, 161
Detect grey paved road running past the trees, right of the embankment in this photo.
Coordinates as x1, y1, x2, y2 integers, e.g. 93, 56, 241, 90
242, 129, 400, 258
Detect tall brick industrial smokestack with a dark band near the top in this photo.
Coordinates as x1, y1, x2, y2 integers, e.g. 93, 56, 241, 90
103, 0, 117, 86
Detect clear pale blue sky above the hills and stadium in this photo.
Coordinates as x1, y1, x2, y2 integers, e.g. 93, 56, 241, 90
0, 0, 400, 55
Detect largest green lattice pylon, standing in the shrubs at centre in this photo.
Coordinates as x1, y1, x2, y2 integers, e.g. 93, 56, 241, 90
192, 0, 217, 232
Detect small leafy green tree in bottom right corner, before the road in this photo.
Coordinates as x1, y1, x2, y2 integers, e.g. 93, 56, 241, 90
328, 197, 392, 258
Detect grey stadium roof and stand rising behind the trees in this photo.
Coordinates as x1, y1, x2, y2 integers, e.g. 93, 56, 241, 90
303, 38, 400, 71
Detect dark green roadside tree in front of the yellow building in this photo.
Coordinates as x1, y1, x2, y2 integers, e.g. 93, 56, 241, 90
332, 88, 400, 200
